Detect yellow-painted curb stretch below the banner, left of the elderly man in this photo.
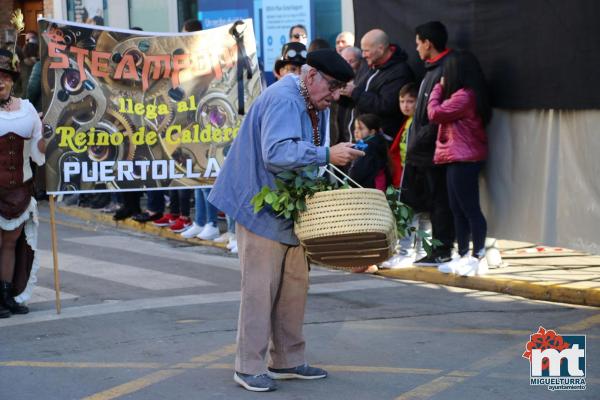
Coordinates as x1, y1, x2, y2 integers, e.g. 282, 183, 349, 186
56, 207, 228, 251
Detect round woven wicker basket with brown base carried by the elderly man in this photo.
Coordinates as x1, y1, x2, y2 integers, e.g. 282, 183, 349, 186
294, 188, 396, 268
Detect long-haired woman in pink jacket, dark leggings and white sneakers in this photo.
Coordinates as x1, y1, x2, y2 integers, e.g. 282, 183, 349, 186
427, 51, 491, 276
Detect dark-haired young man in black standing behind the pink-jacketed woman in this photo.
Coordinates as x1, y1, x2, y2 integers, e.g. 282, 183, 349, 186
402, 21, 454, 266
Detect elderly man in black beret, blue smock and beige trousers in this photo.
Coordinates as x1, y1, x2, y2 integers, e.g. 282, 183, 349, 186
209, 49, 364, 392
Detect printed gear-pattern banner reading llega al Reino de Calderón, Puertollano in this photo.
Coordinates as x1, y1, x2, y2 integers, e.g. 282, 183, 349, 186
39, 19, 261, 194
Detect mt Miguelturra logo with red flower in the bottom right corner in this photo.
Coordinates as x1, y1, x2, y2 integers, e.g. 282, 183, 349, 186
523, 326, 585, 391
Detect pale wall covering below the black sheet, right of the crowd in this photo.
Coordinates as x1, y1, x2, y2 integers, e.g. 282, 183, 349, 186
481, 109, 600, 254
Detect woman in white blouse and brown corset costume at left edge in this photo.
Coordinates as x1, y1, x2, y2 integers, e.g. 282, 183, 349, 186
0, 49, 46, 318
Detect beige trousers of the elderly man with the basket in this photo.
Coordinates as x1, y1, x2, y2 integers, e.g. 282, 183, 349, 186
235, 224, 308, 375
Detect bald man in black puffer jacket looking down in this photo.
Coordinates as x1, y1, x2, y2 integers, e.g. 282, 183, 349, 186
342, 29, 414, 140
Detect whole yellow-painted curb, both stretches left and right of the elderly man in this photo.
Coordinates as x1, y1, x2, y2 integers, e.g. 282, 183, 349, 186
57, 207, 600, 307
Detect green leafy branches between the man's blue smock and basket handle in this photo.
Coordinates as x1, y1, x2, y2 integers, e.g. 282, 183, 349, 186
250, 165, 349, 221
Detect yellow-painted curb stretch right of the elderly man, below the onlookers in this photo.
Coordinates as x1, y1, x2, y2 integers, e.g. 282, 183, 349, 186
376, 267, 600, 307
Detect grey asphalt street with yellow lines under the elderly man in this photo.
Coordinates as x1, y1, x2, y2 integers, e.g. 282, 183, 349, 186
0, 207, 600, 400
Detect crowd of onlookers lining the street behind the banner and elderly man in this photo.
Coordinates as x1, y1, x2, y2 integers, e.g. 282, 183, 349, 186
38, 20, 491, 276
